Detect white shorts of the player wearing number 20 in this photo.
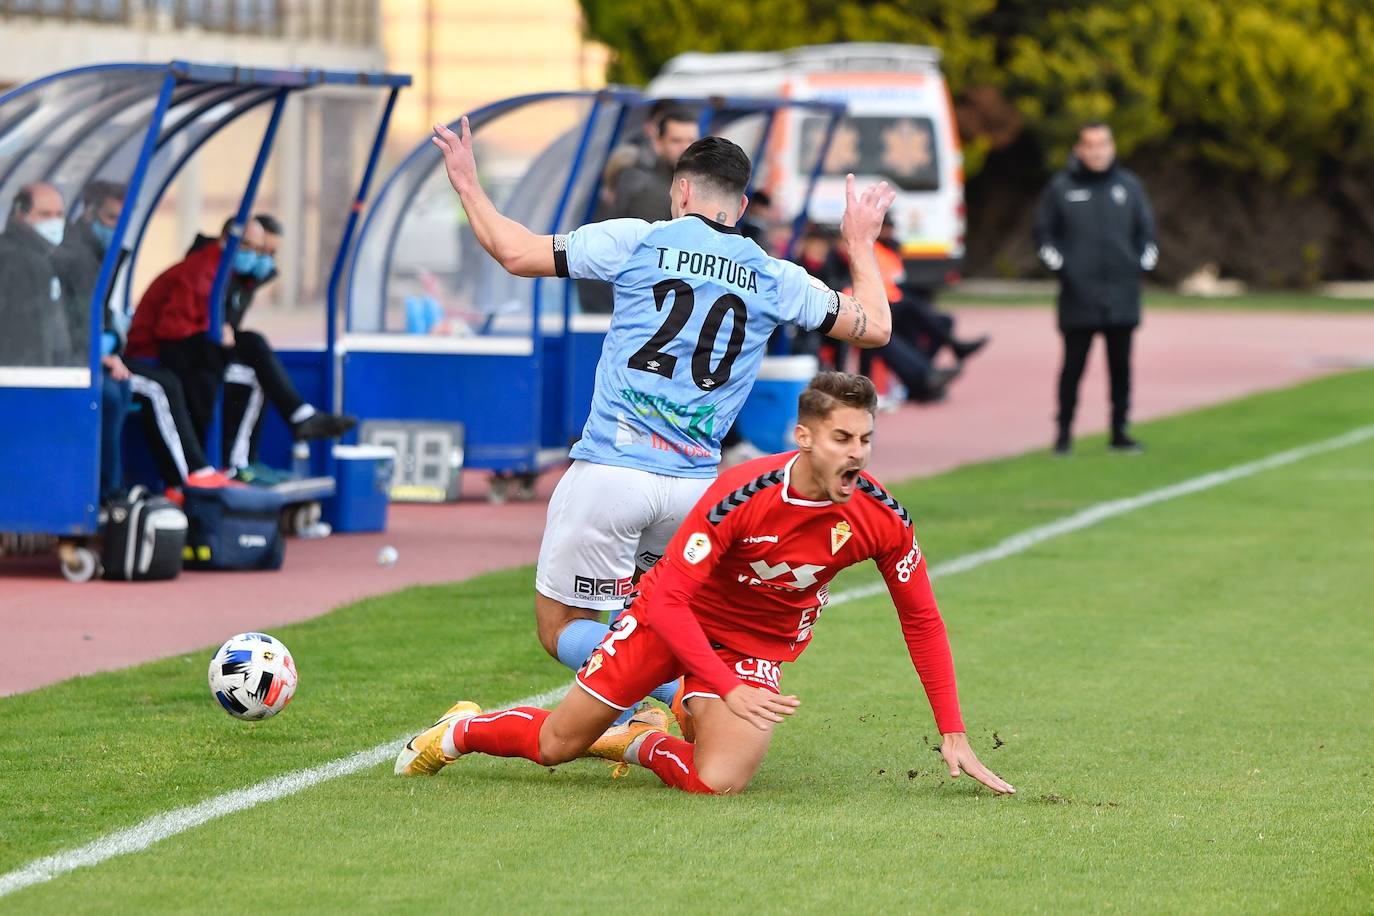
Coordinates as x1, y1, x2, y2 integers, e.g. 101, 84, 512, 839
534, 460, 714, 611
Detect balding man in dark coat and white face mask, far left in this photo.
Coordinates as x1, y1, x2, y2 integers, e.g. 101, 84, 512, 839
0, 181, 73, 367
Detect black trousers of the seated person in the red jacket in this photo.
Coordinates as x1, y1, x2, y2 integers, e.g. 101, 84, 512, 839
158, 331, 305, 442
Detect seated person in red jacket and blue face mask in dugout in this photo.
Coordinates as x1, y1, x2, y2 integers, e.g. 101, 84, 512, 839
128, 218, 357, 472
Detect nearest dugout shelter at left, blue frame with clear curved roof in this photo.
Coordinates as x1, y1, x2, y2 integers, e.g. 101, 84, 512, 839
0, 60, 411, 574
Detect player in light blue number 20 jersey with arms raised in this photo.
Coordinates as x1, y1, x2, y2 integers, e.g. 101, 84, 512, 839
433, 112, 896, 725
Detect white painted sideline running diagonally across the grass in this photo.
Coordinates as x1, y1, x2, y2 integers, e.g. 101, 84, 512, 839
0, 426, 1374, 897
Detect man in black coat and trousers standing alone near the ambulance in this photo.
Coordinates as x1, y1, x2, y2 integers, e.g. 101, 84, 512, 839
1035, 122, 1160, 455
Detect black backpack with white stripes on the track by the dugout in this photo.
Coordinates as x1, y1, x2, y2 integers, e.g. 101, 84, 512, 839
100, 486, 187, 581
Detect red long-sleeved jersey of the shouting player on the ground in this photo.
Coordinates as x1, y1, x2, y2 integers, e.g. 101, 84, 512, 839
632, 452, 963, 732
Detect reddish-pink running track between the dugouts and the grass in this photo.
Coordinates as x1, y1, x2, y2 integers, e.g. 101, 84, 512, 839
0, 306, 1374, 695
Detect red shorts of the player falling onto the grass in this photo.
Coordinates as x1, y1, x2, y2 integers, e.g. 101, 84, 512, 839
577, 612, 782, 710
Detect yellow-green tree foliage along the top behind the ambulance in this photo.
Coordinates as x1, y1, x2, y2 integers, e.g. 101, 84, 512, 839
581, 0, 1374, 191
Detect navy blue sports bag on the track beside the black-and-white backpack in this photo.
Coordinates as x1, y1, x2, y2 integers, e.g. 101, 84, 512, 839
184, 486, 286, 570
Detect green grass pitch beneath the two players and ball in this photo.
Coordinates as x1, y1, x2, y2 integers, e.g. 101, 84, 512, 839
0, 372, 1374, 913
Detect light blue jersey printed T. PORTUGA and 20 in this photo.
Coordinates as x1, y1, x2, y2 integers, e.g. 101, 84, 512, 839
554, 214, 840, 477
